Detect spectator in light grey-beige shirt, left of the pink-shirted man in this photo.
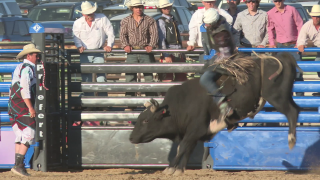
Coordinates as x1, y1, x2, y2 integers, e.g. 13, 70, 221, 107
233, 0, 268, 48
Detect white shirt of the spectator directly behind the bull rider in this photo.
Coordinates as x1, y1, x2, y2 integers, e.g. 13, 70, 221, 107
187, 8, 233, 47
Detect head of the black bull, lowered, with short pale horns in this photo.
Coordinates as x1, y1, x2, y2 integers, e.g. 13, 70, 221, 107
130, 99, 169, 144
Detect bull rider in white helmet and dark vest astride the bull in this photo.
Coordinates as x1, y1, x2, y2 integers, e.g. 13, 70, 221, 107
200, 8, 236, 131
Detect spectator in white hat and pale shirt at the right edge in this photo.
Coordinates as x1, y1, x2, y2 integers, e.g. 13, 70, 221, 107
297, 5, 320, 96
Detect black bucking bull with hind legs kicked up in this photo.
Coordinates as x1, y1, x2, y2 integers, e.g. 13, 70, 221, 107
130, 53, 299, 175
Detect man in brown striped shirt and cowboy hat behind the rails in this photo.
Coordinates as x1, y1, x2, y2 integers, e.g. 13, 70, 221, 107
120, 0, 158, 96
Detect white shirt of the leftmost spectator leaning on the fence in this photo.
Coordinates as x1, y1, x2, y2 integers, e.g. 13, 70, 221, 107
72, 14, 114, 49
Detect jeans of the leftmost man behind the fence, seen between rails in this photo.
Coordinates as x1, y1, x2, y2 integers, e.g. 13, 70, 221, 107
80, 53, 108, 96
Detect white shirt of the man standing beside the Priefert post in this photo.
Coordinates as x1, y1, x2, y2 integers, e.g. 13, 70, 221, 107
11, 59, 37, 99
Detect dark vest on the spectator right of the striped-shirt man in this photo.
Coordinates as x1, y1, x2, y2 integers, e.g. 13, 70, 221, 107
159, 17, 181, 45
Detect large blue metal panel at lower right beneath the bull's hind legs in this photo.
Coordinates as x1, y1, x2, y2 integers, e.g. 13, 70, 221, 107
205, 127, 320, 170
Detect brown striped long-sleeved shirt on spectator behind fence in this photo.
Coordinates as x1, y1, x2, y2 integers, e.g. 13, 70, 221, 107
120, 15, 158, 48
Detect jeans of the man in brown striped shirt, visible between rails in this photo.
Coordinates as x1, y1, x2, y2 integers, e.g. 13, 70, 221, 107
126, 54, 157, 96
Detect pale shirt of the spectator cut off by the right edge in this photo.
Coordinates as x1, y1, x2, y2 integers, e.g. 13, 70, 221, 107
297, 20, 320, 47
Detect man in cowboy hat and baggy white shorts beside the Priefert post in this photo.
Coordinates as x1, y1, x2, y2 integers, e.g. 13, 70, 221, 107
8, 44, 41, 176
